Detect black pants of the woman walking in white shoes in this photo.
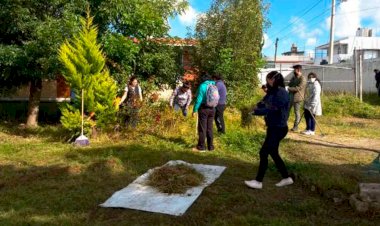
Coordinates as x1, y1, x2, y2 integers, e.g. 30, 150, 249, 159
256, 127, 289, 182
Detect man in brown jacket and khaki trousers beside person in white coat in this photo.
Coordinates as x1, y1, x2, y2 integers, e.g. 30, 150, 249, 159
288, 64, 306, 132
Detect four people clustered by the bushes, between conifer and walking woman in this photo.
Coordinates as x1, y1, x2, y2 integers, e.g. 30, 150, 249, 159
119, 74, 227, 152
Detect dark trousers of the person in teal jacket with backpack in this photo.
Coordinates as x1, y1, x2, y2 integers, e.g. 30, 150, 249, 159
197, 106, 215, 150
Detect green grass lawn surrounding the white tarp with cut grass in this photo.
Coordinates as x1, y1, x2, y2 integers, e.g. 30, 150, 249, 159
0, 95, 380, 225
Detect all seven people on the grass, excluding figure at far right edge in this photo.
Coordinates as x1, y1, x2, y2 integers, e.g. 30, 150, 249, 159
119, 65, 322, 189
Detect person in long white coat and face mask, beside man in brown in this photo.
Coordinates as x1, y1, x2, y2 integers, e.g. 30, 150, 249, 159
302, 72, 322, 135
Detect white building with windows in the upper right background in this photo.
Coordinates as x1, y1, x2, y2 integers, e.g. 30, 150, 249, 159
316, 28, 380, 63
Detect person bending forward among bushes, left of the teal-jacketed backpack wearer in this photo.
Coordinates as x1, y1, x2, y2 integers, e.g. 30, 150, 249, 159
169, 83, 192, 116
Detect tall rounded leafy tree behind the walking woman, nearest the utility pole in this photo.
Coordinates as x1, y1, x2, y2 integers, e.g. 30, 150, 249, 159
195, 0, 267, 103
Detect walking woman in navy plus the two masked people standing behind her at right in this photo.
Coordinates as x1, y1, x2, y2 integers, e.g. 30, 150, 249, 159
245, 65, 322, 189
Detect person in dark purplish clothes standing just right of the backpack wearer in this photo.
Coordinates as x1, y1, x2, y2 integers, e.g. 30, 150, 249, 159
212, 74, 227, 134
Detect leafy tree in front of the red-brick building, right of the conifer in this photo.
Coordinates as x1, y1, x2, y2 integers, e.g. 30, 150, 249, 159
95, 0, 188, 91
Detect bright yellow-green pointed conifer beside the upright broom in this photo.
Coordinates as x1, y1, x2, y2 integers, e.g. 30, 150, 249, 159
59, 13, 117, 132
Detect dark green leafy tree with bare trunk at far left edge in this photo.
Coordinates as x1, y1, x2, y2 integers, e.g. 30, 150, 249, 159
0, 0, 82, 127
